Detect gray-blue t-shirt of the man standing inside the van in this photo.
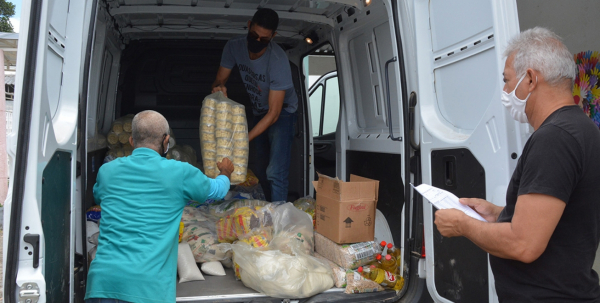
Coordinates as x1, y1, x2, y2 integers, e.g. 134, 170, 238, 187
221, 36, 298, 116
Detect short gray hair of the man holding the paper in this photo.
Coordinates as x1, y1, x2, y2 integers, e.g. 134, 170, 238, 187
504, 27, 577, 86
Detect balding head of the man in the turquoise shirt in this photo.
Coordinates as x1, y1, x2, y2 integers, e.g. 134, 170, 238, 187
131, 110, 169, 150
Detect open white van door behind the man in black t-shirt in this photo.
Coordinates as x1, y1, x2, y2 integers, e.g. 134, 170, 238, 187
414, 0, 529, 302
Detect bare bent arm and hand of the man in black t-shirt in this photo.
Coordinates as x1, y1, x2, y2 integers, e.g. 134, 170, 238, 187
435, 194, 566, 263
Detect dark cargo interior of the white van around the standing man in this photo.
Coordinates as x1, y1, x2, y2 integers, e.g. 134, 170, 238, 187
77, 0, 404, 302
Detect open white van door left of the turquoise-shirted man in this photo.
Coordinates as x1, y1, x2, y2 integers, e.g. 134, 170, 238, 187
4, 0, 96, 303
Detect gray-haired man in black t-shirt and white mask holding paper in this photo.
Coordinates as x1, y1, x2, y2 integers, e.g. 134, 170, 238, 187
435, 27, 600, 302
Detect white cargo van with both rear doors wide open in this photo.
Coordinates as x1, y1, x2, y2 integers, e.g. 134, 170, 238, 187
3, 0, 600, 303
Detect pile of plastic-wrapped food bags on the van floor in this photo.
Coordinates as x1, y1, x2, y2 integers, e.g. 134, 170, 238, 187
182, 200, 334, 298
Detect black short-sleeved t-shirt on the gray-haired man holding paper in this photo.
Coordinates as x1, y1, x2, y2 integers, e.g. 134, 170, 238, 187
490, 105, 600, 302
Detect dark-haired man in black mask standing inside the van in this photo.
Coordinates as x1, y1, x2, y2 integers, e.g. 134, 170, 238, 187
212, 8, 298, 201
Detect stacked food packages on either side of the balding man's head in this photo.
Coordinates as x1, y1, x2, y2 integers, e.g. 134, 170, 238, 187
105, 115, 197, 166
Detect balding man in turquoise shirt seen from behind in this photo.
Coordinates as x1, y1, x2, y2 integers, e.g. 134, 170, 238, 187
86, 110, 233, 303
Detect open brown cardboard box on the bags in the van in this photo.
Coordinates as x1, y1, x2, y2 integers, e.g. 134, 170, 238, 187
313, 174, 379, 244
